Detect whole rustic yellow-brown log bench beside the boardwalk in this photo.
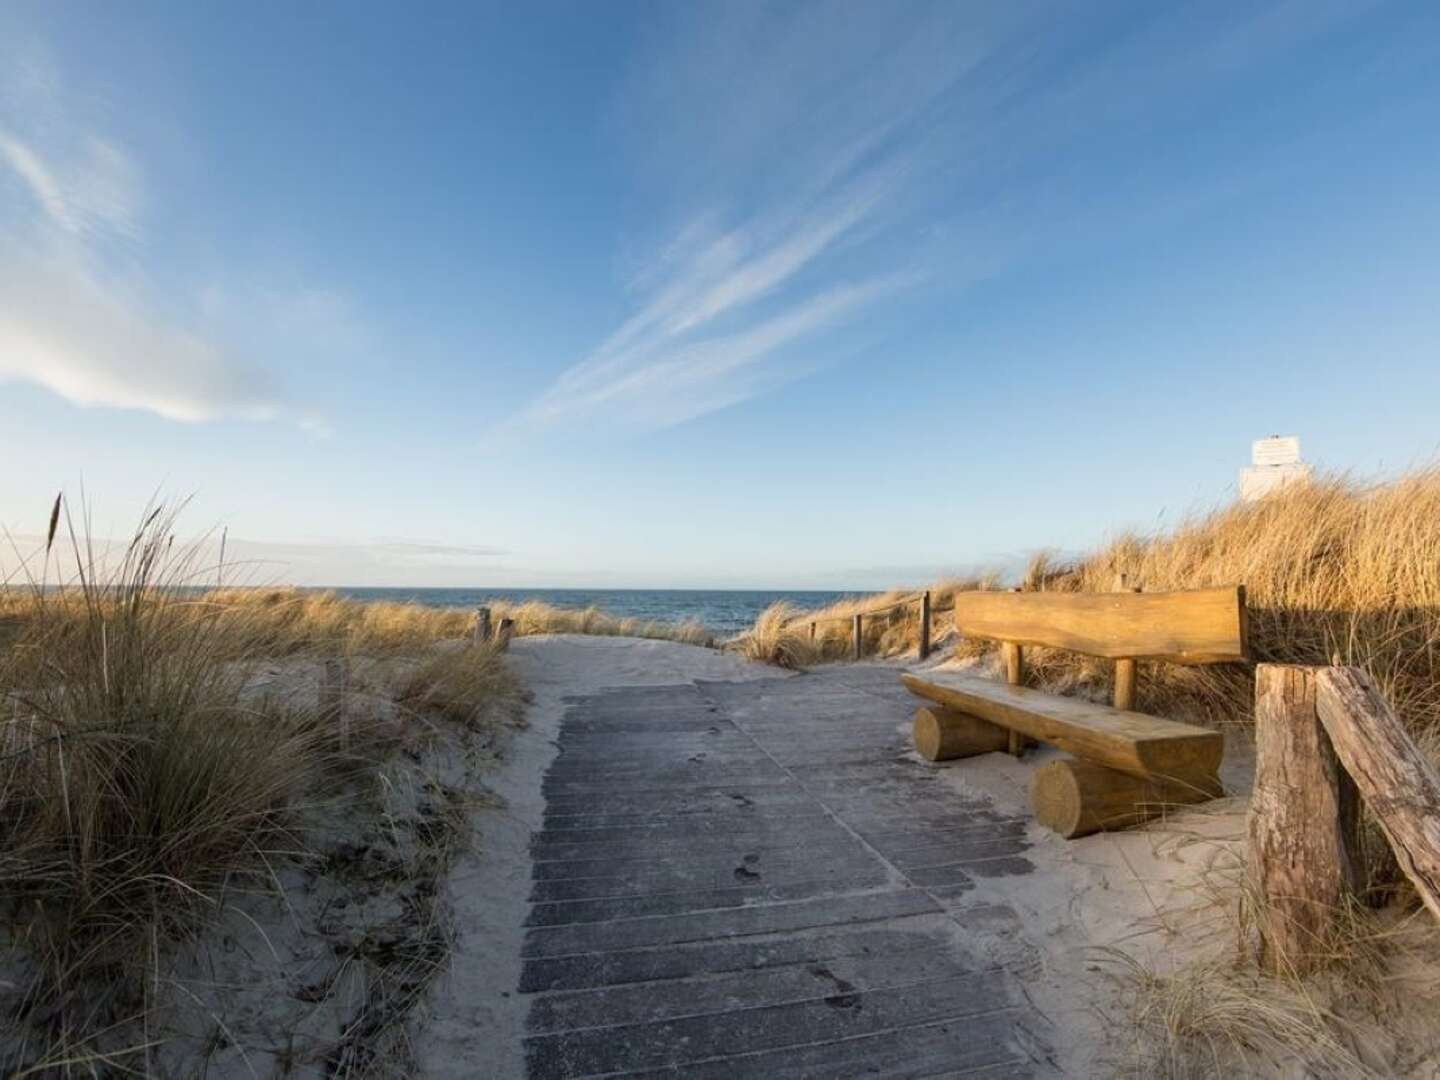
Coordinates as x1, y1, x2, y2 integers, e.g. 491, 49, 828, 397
901, 586, 1247, 837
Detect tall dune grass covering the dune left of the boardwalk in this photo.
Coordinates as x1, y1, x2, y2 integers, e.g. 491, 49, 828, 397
0, 501, 521, 1071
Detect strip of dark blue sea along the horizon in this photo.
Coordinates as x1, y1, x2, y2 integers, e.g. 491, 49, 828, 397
333, 588, 865, 636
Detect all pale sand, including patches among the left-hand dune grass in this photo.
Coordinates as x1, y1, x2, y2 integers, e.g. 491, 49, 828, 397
0, 635, 1370, 1077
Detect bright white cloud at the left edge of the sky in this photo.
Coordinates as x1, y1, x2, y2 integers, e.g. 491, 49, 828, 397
0, 43, 325, 432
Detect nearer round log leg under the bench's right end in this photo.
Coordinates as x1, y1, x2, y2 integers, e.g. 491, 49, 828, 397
1030, 760, 1221, 840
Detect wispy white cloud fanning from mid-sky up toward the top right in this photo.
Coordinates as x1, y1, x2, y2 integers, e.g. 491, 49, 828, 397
520, 0, 1370, 431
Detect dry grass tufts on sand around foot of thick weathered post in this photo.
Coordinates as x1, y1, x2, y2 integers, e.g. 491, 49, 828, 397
1096, 812, 1440, 1080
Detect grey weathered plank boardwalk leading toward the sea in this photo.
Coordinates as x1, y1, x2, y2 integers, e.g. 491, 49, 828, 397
521, 667, 1044, 1080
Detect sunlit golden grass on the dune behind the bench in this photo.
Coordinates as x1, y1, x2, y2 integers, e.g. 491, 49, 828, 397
766, 468, 1440, 732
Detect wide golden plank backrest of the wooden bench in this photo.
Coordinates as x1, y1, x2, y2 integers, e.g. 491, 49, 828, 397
955, 585, 1247, 664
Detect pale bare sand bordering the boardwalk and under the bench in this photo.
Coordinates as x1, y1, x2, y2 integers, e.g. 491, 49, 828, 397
422, 635, 1247, 1077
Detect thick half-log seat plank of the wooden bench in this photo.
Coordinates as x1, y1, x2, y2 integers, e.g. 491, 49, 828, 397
900, 671, 1224, 780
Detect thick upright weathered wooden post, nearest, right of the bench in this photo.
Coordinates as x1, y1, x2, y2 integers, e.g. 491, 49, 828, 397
1246, 664, 1359, 973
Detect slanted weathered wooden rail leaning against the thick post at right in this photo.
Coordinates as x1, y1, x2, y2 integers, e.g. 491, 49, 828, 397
1316, 668, 1440, 919
